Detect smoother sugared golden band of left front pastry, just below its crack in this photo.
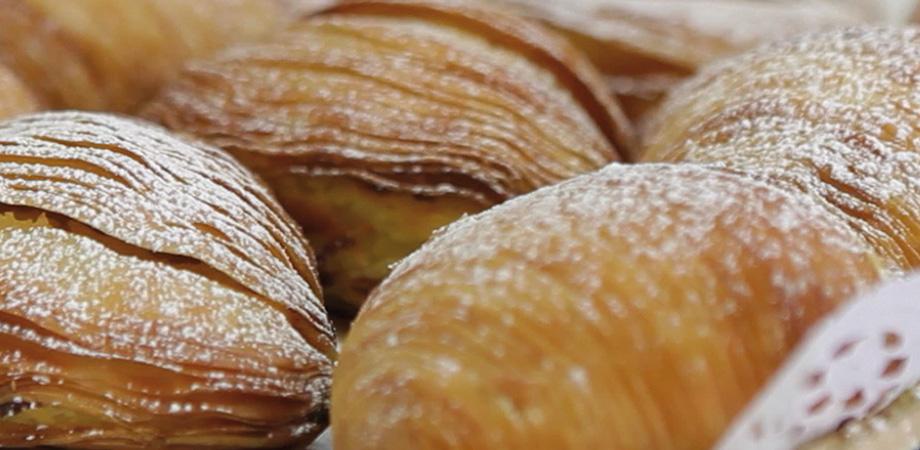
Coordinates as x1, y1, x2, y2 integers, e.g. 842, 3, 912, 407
0, 218, 328, 380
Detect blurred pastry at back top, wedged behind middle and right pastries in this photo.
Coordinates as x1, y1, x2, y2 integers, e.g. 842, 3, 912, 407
486, 0, 863, 125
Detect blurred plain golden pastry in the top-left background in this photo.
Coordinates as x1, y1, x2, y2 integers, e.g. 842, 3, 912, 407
0, 0, 284, 112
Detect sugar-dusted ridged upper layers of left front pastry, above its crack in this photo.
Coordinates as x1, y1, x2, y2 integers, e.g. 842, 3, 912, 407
0, 112, 332, 345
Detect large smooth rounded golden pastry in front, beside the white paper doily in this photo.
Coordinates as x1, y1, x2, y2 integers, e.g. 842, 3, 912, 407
332, 164, 879, 450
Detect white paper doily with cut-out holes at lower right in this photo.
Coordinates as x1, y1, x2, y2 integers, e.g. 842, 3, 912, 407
716, 274, 920, 450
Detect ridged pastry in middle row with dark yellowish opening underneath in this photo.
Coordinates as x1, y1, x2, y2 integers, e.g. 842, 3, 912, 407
144, 1, 631, 309
